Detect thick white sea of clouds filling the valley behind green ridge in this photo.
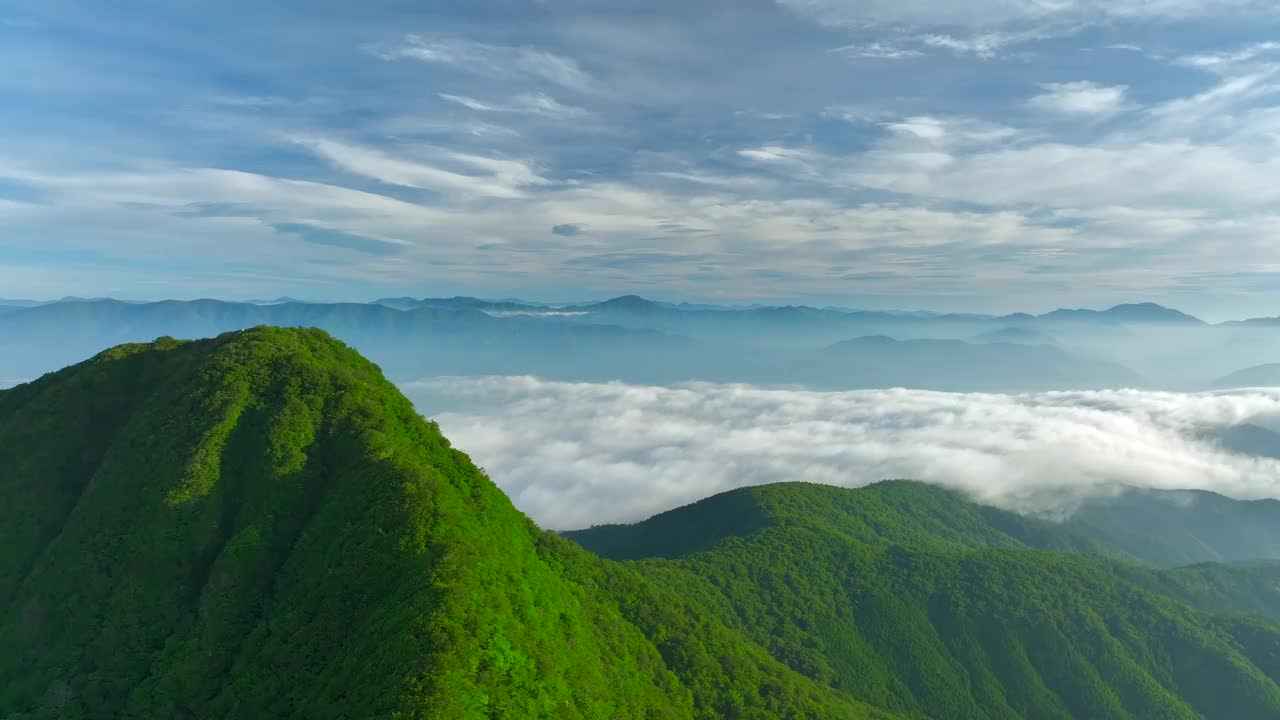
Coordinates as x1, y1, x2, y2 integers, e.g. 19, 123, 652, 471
402, 377, 1280, 529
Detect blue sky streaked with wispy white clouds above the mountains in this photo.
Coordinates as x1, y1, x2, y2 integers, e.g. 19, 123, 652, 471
0, 0, 1280, 318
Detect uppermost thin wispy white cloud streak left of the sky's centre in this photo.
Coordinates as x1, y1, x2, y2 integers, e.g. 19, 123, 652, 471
372, 35, 595, 92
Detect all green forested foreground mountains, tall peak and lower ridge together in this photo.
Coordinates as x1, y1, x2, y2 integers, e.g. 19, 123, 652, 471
0, 328, 1280, 720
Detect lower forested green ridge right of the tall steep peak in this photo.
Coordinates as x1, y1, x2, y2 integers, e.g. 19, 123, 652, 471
570, 483, 1280, 720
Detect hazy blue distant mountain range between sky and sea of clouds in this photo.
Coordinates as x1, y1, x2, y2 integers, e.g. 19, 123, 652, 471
0, 295, 1280, 391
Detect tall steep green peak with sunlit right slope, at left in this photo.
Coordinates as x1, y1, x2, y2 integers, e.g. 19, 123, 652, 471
0, 328, 883, 719
